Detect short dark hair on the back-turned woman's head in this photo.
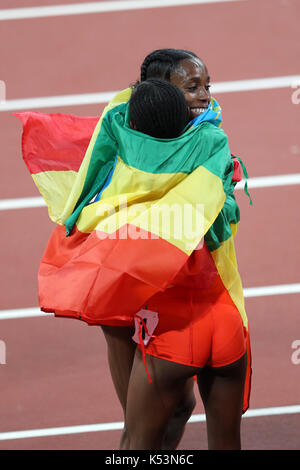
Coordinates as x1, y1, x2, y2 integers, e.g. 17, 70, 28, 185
129, 79, 189, 139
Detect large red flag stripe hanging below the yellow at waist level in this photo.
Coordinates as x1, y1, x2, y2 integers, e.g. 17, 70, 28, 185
39, 226, 188, 325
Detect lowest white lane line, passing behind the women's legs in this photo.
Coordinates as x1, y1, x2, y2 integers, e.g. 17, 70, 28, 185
0, 405, 300, 441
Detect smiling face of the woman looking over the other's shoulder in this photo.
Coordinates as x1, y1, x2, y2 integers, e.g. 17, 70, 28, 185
170, 58, 211, 120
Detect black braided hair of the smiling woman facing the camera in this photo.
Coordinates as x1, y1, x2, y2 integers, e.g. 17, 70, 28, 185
140, 49, 199, 82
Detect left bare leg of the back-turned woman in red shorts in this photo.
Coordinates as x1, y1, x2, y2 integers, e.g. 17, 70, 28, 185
125, 349, 199, 450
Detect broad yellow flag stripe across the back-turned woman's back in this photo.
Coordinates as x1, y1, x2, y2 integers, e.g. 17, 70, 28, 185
76, 159, 225, 255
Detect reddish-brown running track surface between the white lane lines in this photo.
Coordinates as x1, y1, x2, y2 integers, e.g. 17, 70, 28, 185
0, 0, 300, 449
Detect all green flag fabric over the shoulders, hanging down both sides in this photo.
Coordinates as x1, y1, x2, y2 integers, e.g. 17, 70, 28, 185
65, 103, 244, 250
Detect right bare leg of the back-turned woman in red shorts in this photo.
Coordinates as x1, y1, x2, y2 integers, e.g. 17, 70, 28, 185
198, 354, 247, 450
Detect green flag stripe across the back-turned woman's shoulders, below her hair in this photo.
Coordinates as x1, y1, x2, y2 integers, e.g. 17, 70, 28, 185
111, 104, 231, 177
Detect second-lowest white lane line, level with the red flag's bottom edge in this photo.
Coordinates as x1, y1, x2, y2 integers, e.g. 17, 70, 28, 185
0, 283, 300, 320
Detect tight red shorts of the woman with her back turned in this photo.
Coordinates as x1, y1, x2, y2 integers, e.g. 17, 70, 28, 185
137, 275, 247, 368
